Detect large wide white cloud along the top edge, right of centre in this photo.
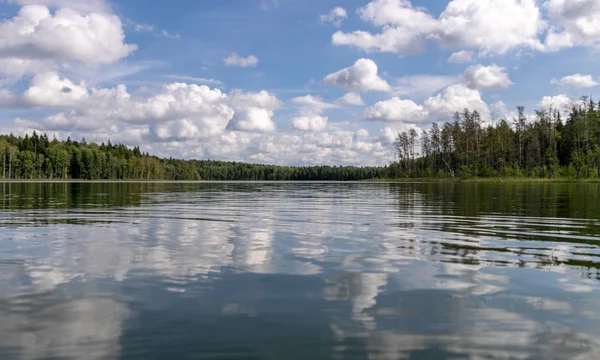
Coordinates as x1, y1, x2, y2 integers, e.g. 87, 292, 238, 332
332, 0, 546, 55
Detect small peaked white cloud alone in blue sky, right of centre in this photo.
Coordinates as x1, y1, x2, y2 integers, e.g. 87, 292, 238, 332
323, 59, 391, 91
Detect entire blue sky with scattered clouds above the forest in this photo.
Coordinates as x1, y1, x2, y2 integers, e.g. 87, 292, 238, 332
0, 0, 600, 165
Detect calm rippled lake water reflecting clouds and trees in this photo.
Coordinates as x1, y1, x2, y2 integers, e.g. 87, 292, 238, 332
0, 183, 600, 360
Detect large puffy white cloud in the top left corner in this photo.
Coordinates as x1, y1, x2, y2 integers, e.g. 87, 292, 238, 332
0, 5, 137, 65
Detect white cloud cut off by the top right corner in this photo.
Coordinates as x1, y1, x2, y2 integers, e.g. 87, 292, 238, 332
544, 0, 600, 51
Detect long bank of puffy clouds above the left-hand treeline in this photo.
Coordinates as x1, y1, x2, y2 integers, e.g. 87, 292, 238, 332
17, 73, 282, 136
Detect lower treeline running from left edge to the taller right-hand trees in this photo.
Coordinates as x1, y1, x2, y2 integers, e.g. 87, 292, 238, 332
0, 132, 388, 181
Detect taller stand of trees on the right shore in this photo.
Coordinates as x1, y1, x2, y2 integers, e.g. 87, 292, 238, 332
389, 97, 600, 178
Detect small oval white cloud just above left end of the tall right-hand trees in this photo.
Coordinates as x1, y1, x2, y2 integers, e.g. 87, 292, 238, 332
365, 97, 429, 124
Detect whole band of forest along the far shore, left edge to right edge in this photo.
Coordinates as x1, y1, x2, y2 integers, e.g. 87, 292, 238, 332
0, 98, 600, 181
